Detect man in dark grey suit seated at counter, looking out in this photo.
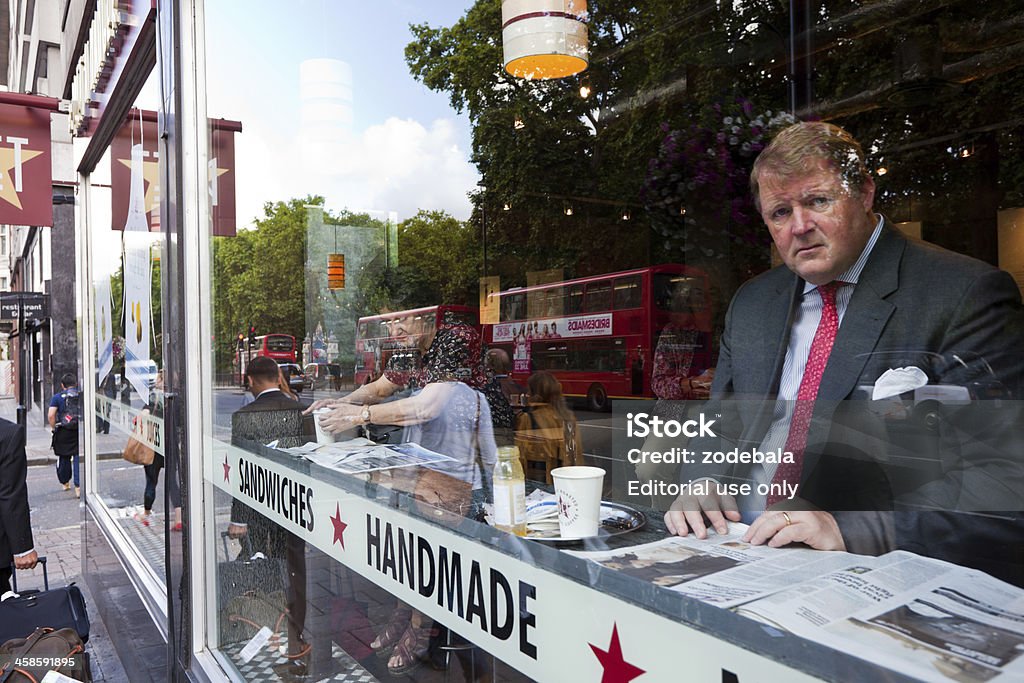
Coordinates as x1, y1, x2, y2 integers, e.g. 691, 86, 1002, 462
666, 122, 1024, 577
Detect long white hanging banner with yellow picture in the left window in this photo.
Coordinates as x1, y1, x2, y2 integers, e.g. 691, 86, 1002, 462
124, 239, 153, 400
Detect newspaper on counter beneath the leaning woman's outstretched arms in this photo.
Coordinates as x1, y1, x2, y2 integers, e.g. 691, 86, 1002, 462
284, 438, 453, 474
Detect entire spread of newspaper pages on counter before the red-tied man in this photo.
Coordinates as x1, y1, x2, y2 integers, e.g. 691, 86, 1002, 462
565, 523, 1024, 682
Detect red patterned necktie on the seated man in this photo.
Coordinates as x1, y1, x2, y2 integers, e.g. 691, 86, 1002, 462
765, 282, 843, 507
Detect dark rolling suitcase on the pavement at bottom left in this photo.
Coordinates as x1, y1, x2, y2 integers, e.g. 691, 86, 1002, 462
0, 557, 89, 643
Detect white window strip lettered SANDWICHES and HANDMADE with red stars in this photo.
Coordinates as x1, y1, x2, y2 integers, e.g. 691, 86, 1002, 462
206, 444, 815, 683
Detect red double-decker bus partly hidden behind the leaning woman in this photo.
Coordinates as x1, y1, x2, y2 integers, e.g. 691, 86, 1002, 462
355, 304, 480, 384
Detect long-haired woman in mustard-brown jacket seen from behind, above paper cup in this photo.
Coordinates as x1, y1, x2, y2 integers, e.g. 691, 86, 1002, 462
515, 371, 584, 483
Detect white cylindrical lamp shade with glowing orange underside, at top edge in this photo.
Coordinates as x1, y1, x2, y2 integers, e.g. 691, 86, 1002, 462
502, 0, 589, 79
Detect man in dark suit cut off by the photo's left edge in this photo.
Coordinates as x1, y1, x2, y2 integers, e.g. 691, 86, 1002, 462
0, 419, 38, 595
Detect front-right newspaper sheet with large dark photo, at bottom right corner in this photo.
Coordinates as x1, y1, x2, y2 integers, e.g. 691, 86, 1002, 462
736, 551, 1024, 681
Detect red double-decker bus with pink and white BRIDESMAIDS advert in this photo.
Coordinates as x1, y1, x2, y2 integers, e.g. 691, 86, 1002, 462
483, 263, 712, 411
